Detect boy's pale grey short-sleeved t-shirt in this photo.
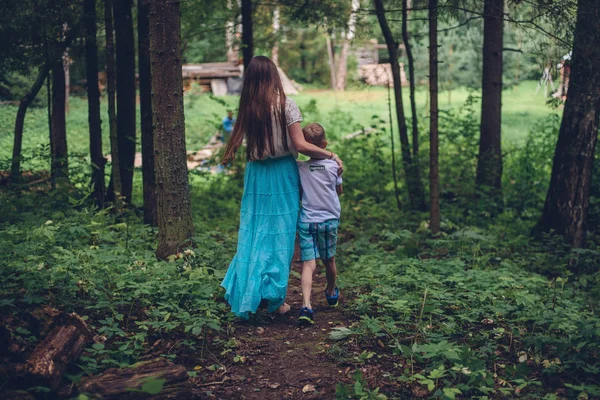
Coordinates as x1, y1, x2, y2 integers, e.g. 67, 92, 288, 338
298, 159, 342, 222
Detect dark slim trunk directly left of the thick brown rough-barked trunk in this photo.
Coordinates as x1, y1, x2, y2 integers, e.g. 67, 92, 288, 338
138, 0, 158, 226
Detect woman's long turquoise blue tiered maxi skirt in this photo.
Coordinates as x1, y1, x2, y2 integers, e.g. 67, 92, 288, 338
221, 156, 300, 318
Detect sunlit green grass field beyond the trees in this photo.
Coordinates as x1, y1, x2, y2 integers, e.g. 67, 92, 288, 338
0, 82, 554, 169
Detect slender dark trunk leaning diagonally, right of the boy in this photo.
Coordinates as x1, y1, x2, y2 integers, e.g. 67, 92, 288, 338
374, 0, 426, 211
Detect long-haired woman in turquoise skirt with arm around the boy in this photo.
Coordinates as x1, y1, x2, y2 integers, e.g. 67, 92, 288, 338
221, 56, 343, 318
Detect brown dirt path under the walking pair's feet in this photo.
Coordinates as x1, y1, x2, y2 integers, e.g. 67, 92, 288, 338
206, 255, 351, 400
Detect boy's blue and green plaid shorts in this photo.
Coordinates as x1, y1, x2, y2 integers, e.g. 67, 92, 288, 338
298, 219, 340, 261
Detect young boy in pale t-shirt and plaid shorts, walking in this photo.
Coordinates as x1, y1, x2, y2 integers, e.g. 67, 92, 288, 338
298, 124, 342, 325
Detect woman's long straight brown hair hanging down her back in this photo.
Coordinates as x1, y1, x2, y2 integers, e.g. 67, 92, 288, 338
223, 56, 288, 165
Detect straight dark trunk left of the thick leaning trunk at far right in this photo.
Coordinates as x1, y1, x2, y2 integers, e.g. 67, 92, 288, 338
476, 0, 504, 200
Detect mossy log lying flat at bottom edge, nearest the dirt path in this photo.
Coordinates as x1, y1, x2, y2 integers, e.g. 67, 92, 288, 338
77, 359, 192, 399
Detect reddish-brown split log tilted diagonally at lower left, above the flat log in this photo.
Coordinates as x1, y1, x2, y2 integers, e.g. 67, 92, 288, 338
25, 313, 92, 389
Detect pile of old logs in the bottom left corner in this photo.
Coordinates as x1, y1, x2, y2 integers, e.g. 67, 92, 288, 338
0, 307, 194, 400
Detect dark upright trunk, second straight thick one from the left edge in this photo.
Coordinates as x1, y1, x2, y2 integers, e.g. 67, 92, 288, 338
83, 0, 106, 208
